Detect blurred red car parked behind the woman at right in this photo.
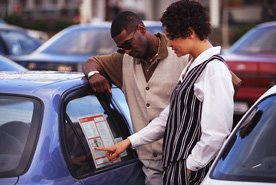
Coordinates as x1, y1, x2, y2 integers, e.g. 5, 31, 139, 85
223, 21, 276, 122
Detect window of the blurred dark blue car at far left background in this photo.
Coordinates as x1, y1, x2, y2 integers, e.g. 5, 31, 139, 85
0, 30, 39, 55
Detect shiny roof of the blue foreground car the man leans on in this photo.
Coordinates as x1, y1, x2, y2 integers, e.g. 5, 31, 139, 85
0, 71, 85, 97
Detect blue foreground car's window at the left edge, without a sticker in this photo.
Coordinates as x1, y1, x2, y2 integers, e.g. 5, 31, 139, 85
0, 95, 41, 177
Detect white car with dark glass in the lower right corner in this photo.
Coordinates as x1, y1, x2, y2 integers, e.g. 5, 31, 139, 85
202, 85, 276, 185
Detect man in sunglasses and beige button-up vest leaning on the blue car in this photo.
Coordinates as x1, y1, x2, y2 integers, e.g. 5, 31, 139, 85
83, 11, 188, 185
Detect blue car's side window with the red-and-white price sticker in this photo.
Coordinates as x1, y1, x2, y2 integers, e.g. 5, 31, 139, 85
63, 90, 136, 178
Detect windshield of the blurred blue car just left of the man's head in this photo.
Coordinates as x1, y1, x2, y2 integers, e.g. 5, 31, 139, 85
43, 27, 116, 55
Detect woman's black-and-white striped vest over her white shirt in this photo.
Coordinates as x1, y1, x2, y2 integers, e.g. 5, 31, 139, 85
163, 56, 218, 168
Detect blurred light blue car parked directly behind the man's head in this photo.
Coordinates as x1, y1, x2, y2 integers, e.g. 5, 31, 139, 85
13, 21, 162, 71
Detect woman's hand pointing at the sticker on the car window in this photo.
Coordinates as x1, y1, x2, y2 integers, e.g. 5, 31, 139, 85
95, 138, 131, 161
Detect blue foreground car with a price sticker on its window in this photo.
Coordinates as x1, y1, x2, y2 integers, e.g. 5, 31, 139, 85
0, 71, 144, 185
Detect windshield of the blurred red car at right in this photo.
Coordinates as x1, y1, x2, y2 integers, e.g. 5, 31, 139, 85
230, 27, 276, 54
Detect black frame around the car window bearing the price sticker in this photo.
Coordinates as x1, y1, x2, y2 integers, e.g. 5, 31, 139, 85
59, 85, 138, 179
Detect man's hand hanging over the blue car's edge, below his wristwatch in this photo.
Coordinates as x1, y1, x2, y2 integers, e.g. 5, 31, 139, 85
89, 74, 111, 93
